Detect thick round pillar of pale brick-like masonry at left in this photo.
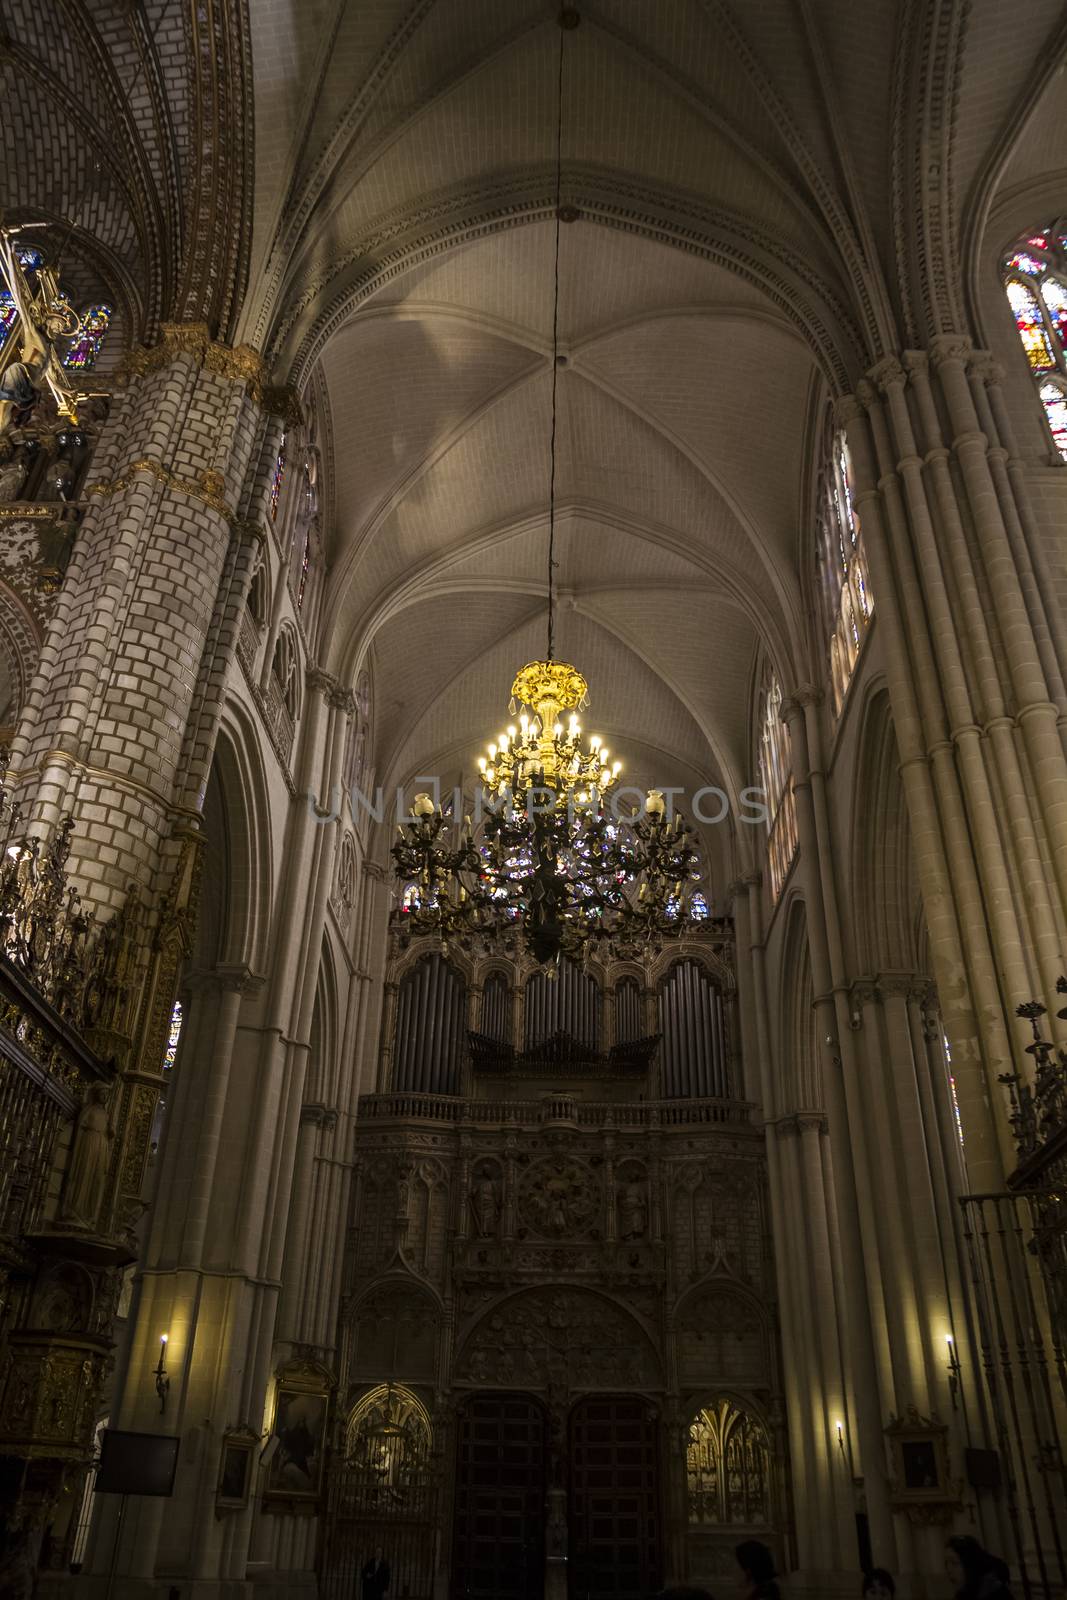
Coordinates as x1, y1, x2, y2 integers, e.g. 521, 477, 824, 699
13, 340, 262, 910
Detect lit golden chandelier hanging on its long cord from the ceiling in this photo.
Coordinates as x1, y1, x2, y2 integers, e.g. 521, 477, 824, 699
392, 8, 707, 966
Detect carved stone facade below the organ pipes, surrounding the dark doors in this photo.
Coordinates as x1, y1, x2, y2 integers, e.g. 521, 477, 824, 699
338, 1094, 789, 1582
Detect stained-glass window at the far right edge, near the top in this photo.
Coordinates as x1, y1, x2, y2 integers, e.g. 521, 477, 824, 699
1003, 219, 1067, 461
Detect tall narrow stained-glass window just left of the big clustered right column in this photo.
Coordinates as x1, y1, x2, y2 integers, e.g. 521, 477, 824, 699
816, 414, 873, 712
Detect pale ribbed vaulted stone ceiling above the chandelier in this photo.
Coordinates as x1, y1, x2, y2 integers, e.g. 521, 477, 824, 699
10, 0, 1067, 889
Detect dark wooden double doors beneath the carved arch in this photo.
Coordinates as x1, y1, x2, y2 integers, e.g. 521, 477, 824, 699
453, 1395, 661, 1600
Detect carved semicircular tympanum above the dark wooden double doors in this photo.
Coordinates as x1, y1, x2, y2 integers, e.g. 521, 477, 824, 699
456, 1288, 659, 1392
